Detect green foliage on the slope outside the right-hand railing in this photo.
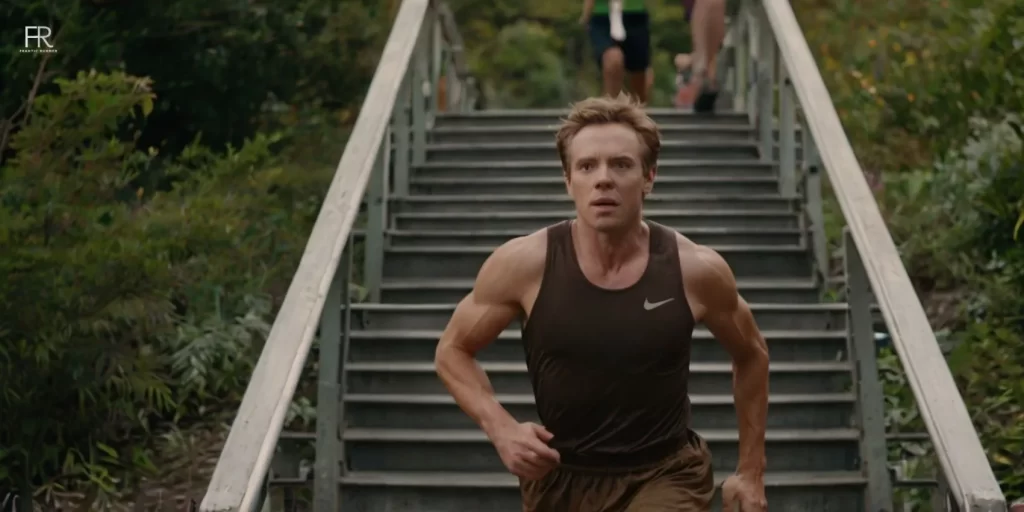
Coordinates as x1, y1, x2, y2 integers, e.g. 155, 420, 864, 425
796, 0, 1024, 500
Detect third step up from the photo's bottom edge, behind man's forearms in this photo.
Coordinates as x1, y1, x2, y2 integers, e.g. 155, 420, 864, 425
343, 392, 856, 431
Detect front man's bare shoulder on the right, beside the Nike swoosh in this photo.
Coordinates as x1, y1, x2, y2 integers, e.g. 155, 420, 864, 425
676, 233, 739, 310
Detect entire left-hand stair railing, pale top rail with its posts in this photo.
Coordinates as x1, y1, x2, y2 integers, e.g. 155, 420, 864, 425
200, 0, 474, 512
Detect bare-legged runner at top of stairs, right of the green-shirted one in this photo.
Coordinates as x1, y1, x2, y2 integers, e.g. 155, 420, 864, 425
679, 0, 725, 113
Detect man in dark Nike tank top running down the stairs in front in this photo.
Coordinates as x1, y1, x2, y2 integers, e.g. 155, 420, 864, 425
435, 95, 768, 512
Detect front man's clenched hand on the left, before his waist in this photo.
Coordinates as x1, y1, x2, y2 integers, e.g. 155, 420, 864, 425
492, 422, 559, 480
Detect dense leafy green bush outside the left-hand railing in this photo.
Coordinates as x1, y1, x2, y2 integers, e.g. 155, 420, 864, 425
0, 72, 330, 500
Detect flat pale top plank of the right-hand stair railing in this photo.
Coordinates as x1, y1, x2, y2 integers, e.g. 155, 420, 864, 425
760, 0, 1007, 511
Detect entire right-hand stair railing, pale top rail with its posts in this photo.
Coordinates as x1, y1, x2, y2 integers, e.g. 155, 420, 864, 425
737, 0, 1007, 512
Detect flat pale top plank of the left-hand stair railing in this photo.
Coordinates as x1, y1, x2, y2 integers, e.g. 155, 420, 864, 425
201, 0, 429, 512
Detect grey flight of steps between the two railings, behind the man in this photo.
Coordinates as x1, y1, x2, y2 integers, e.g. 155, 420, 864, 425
313, 110, 864, 512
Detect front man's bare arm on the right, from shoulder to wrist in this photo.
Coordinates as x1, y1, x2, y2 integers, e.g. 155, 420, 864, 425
683, 246, 768, 481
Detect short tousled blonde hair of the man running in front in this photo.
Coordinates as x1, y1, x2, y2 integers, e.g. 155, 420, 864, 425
555, 93, 662, 174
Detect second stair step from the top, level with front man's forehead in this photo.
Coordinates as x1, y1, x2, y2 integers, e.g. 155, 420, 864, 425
428, 120, 757, 143
